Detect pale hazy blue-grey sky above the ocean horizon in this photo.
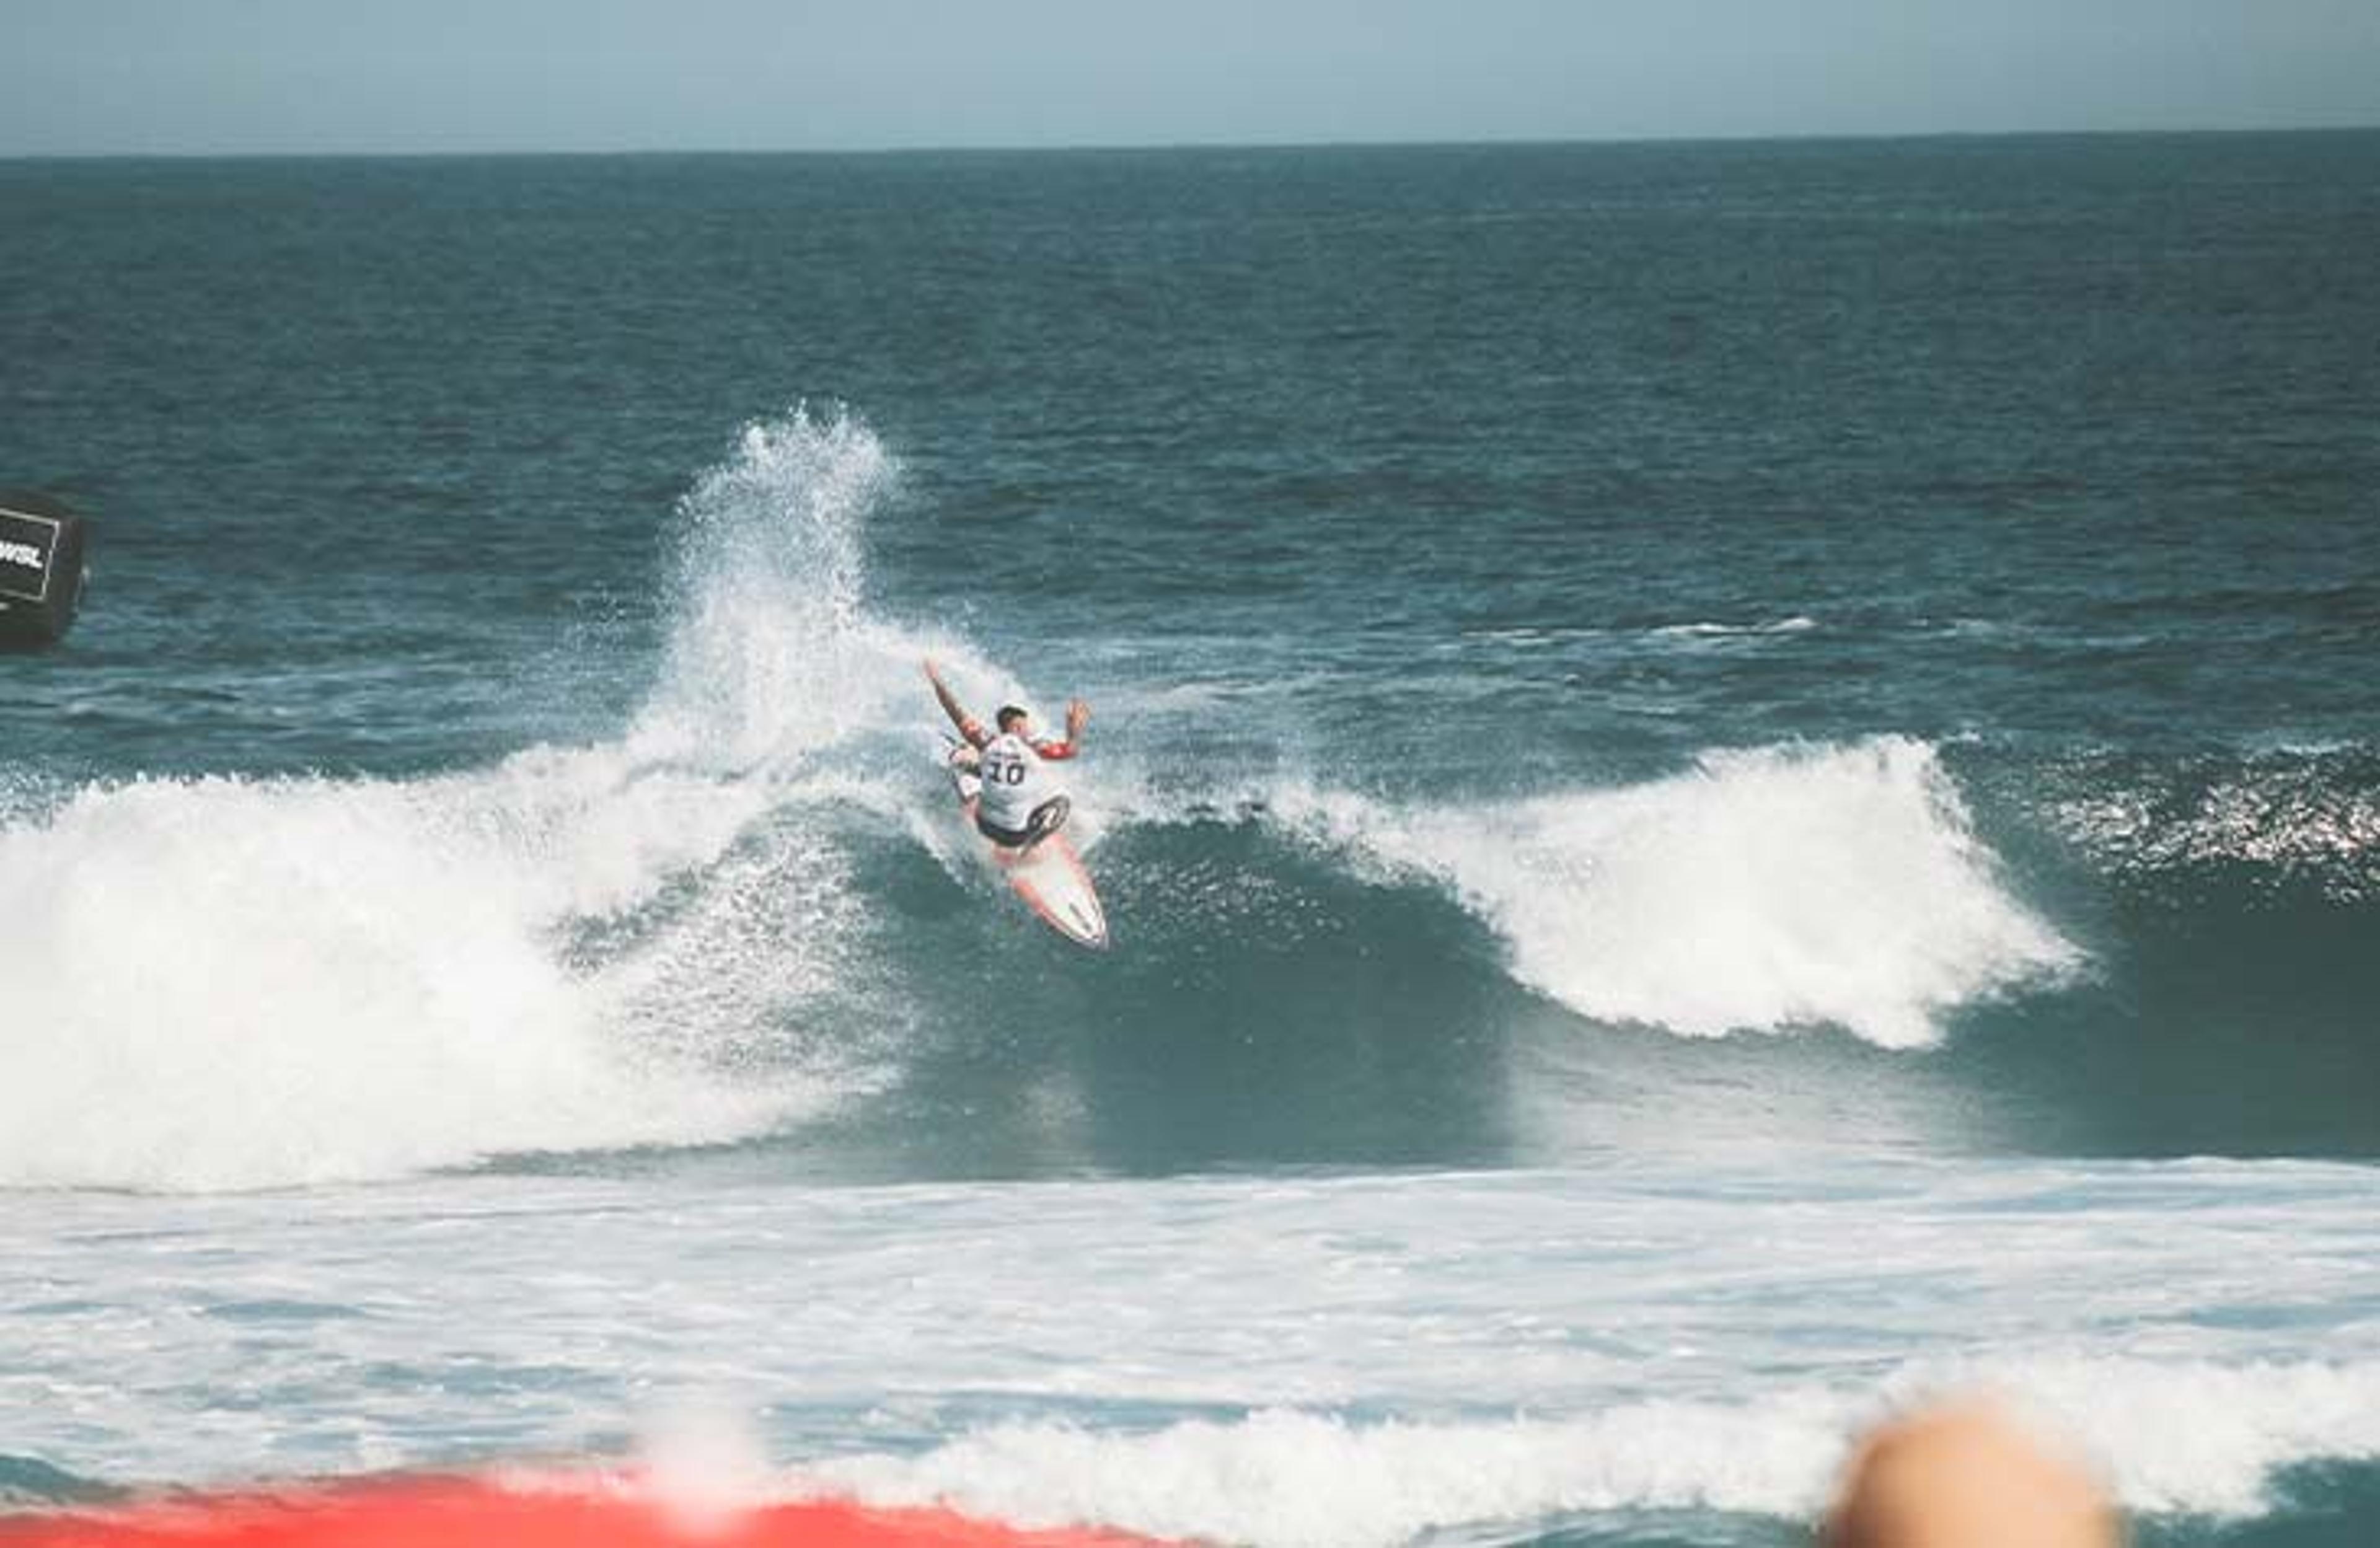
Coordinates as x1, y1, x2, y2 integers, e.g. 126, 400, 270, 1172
0, 0, 2380, 154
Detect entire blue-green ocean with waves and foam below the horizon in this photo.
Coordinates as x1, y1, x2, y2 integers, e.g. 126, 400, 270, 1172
0, 133, 2380, 1548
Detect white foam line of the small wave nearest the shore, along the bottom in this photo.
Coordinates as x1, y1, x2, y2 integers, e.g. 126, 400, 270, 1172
781, 1358, 2380, 1548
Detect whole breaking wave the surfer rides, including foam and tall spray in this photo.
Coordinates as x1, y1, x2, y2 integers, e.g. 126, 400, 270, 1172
14, 411, 2380, 1189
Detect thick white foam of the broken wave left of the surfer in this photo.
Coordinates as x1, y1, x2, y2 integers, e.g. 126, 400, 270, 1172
0, 780, 800, 1189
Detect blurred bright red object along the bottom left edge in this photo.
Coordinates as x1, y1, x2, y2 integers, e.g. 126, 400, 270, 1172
0, 1479, 1152, 1548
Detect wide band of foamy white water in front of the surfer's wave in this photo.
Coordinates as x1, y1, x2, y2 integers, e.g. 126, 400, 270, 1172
0, 1156, 2380, 1521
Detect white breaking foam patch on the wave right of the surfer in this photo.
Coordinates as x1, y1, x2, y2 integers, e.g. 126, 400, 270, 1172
1273, 737, 2080, 1049
